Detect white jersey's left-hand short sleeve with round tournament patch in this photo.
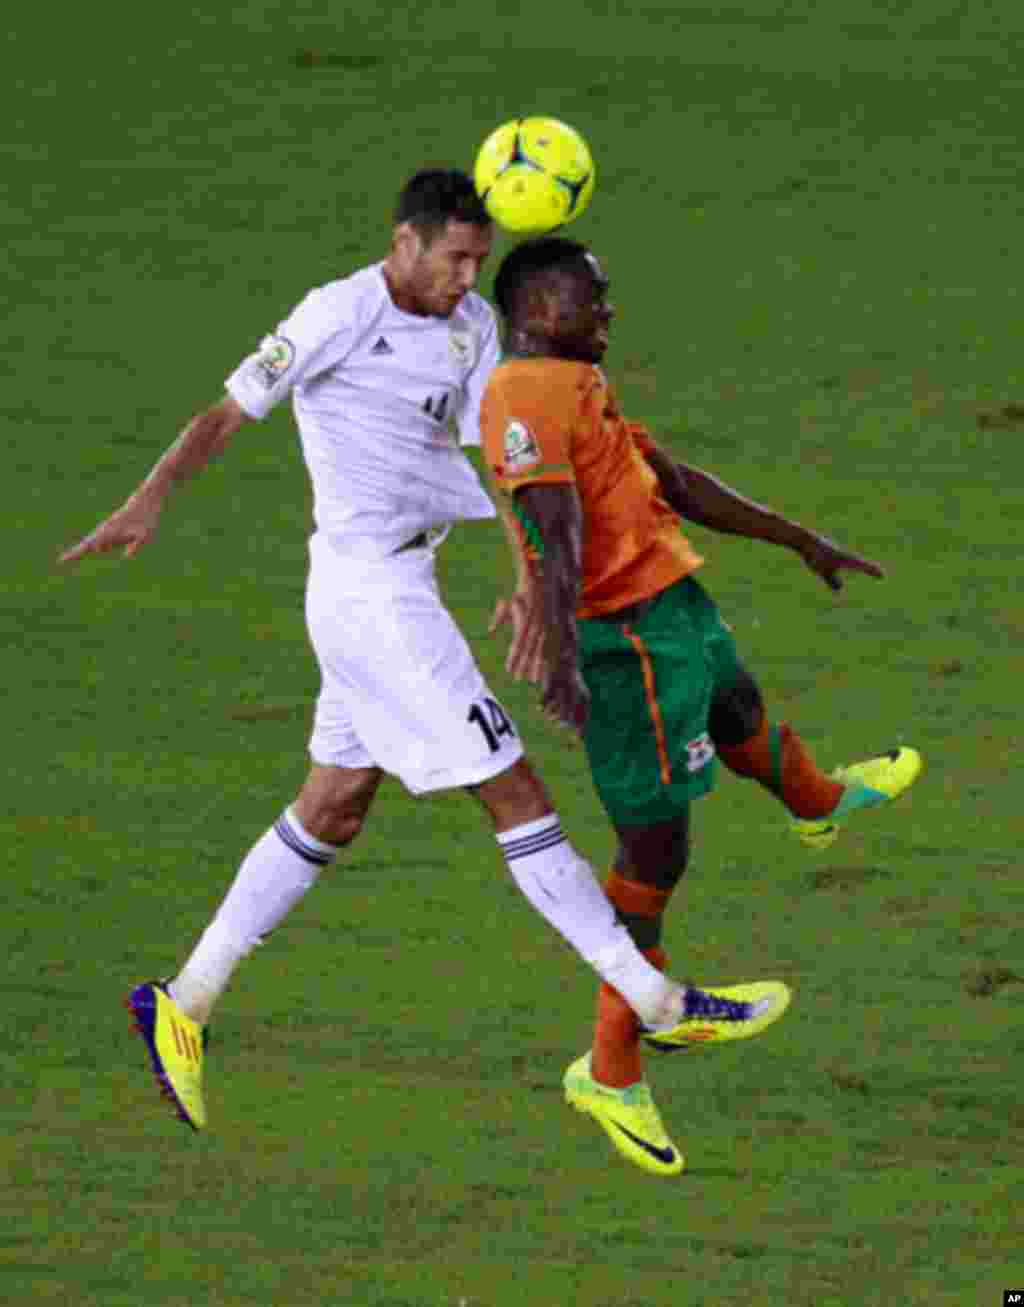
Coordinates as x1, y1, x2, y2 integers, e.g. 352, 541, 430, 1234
225, 284, 357, 418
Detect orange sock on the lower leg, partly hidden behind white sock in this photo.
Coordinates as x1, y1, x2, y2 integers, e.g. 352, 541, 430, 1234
590, 872, 672, 1089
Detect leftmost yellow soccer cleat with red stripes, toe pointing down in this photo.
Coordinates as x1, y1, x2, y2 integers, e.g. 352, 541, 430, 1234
124, 980, 207, 1131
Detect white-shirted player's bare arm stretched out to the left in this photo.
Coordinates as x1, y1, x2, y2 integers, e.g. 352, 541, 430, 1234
58, 395, 248, 563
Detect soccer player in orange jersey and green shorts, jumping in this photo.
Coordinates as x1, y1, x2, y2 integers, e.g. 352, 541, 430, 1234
480, 237, 921, 1174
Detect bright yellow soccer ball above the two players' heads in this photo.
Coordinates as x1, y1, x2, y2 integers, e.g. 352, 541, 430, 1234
473, 118, 595, 237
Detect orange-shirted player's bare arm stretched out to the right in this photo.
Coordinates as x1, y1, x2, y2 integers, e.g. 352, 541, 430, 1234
645, 447, 884, 589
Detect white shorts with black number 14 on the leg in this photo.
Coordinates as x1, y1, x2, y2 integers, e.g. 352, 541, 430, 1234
306, 535, 523, 795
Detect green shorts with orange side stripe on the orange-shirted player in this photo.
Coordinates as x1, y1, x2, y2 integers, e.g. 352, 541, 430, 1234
578, 576, 742, 826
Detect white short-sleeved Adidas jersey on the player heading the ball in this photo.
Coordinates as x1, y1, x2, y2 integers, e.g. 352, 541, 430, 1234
225, 263, 500, 558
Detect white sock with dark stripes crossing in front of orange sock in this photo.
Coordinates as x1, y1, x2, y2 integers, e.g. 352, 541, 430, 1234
497, 813, 681, 1026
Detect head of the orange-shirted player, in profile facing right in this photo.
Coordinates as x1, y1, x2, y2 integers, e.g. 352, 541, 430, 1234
494, 237, 615, 363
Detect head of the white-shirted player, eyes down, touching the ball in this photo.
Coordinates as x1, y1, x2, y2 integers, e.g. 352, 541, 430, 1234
384, 169, 494, 318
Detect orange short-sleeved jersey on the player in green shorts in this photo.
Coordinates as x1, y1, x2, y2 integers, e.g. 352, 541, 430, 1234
480, 358, 704, 617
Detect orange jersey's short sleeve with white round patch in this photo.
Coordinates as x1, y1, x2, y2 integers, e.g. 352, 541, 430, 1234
480, 361, 582, 493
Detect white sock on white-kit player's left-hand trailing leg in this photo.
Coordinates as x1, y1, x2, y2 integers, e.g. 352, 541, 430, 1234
167, 808, 337, 1023
